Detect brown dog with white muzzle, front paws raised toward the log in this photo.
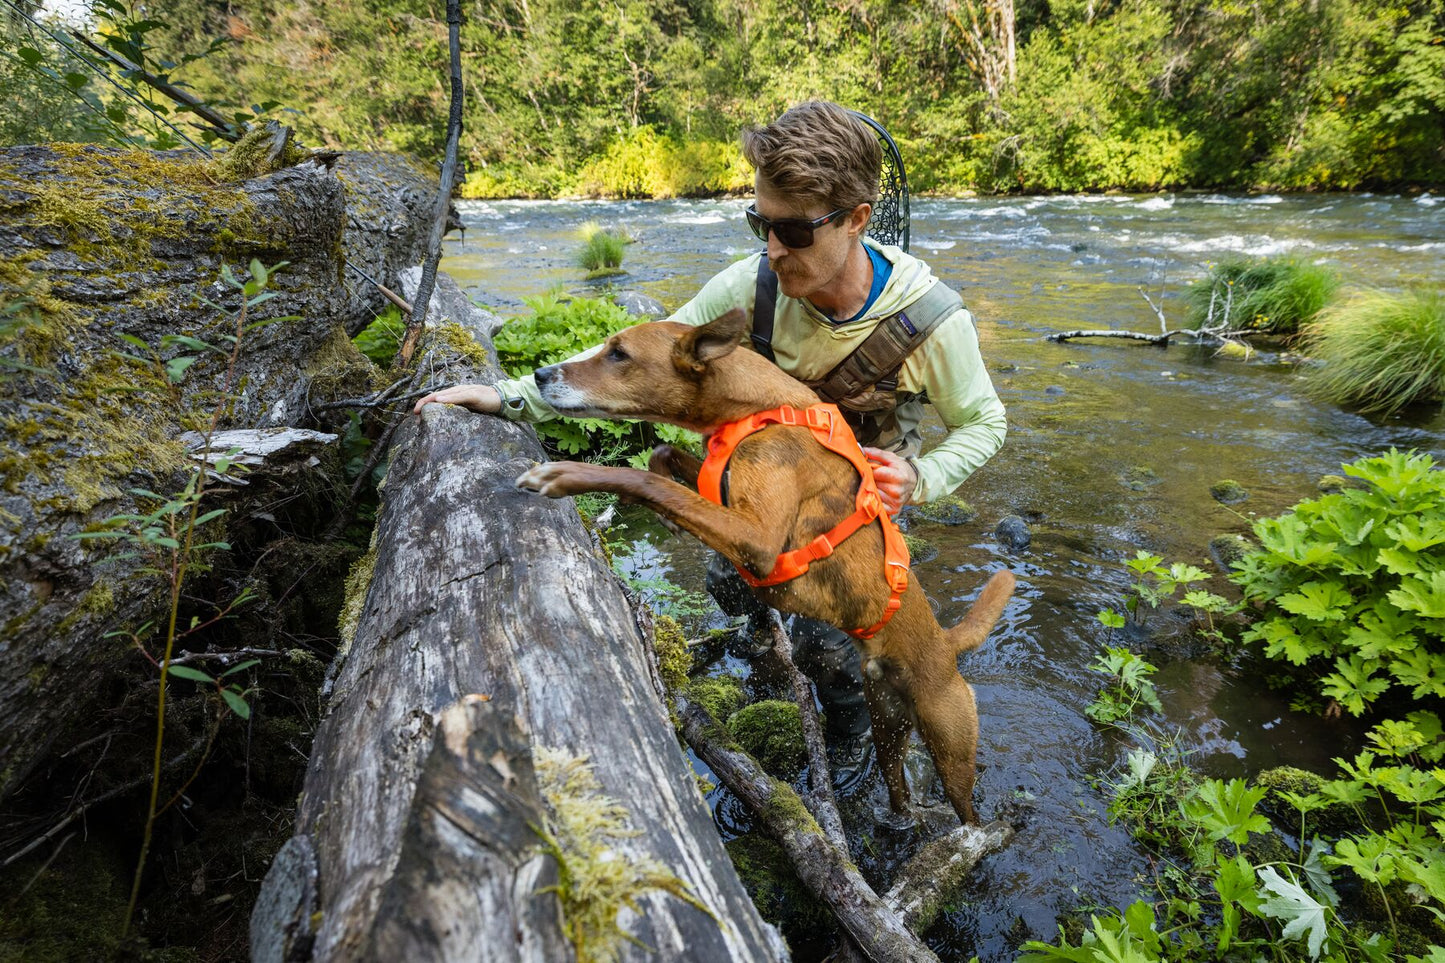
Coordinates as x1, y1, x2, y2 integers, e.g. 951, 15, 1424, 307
517, 311, 1014, 823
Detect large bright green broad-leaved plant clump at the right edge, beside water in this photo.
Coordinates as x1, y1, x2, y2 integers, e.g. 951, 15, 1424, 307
1231, 450, 1445, 716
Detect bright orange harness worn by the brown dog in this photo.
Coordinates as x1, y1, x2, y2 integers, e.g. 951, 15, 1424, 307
698, 403, 909, 639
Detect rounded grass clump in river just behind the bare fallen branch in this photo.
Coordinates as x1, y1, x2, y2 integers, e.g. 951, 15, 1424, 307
1185, 257, 1340, 335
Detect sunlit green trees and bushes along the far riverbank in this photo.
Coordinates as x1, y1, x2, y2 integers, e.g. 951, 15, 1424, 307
0, 0, 1445, 197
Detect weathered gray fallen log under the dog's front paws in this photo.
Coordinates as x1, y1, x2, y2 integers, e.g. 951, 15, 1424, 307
253, 275, 786, 963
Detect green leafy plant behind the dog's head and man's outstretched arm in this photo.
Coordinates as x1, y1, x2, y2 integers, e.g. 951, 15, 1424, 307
493, 295, 699, 467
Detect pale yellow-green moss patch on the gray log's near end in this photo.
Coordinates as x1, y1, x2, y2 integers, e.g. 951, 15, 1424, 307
535, 746, 711, 963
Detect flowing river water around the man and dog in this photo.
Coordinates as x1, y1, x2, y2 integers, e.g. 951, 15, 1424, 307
442, 195, 1445, 962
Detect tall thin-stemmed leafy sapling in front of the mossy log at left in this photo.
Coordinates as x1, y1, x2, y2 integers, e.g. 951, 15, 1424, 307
75, 260, 295, 931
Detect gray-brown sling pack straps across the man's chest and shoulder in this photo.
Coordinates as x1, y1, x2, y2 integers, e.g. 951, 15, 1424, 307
751, 256, 964, 406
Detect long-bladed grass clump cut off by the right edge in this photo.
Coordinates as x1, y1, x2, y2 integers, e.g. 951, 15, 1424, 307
1305, 289, 1445, 414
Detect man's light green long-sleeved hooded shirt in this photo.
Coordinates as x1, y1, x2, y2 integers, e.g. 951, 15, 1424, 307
496, 240, 1007, 502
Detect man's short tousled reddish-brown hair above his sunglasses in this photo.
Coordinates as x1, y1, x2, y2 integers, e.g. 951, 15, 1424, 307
743, 100, 883, 211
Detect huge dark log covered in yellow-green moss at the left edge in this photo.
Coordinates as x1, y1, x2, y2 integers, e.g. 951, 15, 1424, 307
0, 145, 436, 798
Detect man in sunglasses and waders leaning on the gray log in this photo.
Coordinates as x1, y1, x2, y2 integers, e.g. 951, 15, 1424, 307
416, 101, 1006, 788
